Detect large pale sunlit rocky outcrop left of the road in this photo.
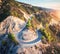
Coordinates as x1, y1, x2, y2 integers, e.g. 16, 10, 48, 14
0, 16, 25, 32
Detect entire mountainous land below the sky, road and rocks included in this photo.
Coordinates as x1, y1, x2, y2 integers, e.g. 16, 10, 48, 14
0, 0, 60, 54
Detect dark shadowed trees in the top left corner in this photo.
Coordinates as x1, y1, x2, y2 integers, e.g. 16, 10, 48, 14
0, 0, 10, 22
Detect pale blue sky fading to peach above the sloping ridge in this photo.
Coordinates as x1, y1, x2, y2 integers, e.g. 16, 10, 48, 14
17, 0, 60, 10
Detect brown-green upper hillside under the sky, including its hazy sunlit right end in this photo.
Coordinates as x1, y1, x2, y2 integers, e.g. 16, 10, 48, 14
0, 0, 60, 36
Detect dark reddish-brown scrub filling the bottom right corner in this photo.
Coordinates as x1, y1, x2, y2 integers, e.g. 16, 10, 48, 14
42, 43, 60, 54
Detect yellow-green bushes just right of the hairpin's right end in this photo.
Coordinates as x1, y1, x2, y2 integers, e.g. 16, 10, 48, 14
40, 23, 58, 43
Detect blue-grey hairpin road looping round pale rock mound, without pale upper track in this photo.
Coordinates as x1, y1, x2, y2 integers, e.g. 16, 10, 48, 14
16, 9, 42, 46
